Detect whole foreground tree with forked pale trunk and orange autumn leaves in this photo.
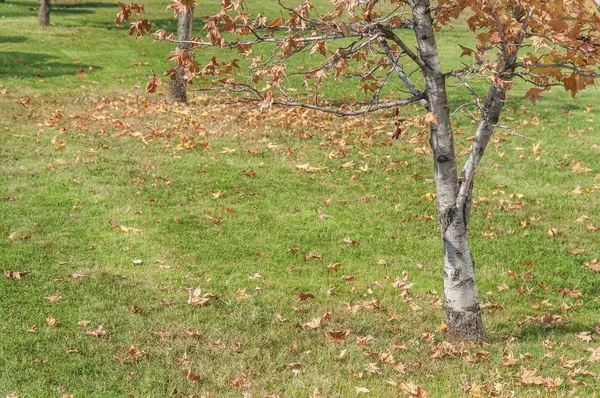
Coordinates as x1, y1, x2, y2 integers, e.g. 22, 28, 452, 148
117, 0, 600, 341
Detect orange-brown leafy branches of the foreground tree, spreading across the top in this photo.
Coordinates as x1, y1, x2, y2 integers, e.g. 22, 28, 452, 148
115, 0, 600, 112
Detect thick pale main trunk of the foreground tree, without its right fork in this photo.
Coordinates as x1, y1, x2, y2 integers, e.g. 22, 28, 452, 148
413, 0, 486, 341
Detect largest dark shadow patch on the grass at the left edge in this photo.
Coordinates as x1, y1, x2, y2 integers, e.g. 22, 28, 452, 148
0, 51, 102, 79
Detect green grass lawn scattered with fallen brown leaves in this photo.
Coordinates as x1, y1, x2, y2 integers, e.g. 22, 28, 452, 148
0, 1, 600, 397
